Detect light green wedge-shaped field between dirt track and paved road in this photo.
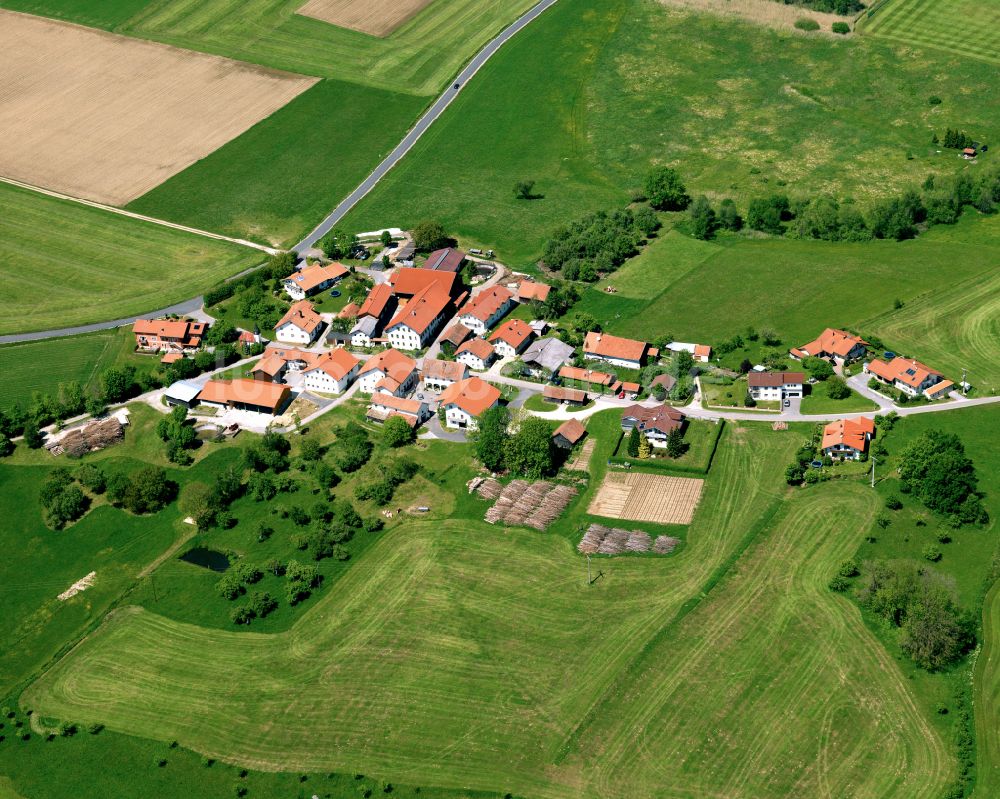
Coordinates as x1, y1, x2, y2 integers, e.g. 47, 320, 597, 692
0, 184, 261, 334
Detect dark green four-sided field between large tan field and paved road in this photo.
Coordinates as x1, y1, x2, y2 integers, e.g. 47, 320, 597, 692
128, 80, 424, 245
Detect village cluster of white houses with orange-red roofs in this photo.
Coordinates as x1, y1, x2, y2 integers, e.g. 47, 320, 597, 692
111, 231, 968, 472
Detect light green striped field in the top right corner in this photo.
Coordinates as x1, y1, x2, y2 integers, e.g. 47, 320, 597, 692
861, 0, 1000, 64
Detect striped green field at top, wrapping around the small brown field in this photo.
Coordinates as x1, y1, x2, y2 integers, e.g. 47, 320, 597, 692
0, 0, 534, 95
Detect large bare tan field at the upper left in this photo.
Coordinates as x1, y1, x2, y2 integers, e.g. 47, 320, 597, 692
0, 10, 316, 205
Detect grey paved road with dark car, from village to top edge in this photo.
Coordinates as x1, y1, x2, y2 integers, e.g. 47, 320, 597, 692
295, 0, 556, 253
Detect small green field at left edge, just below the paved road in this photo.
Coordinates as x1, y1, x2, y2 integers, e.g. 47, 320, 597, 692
0, 330, 120, 409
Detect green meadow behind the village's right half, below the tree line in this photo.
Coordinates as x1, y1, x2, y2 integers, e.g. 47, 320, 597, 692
574, 215, 1000, 372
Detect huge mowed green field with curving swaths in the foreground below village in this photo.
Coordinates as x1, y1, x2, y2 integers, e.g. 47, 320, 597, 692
22, 426, 952, 797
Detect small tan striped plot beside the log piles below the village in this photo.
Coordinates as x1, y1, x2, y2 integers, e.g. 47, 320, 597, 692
587, 472, 705, 524
